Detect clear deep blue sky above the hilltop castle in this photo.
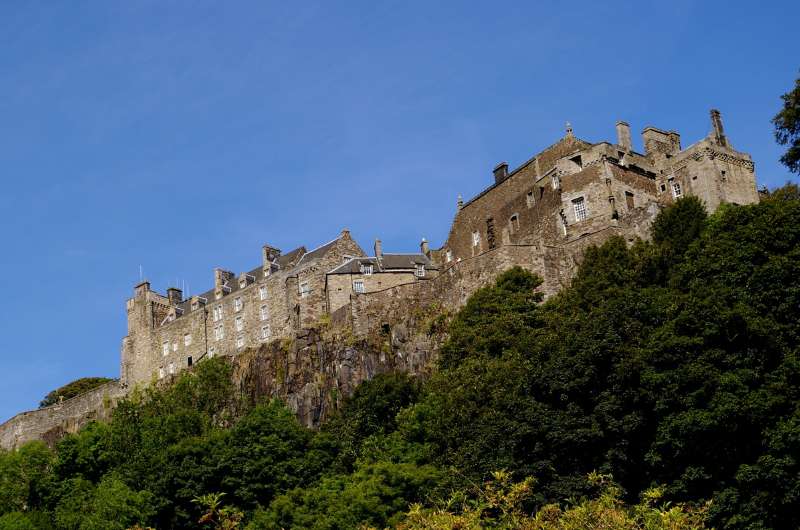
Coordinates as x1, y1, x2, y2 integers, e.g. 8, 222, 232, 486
0, 0, 800, 419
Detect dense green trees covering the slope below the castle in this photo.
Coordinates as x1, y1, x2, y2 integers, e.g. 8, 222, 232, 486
0, 186, 800, 529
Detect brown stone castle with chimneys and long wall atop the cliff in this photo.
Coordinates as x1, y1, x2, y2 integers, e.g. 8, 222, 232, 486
0, 110, 759, 447
